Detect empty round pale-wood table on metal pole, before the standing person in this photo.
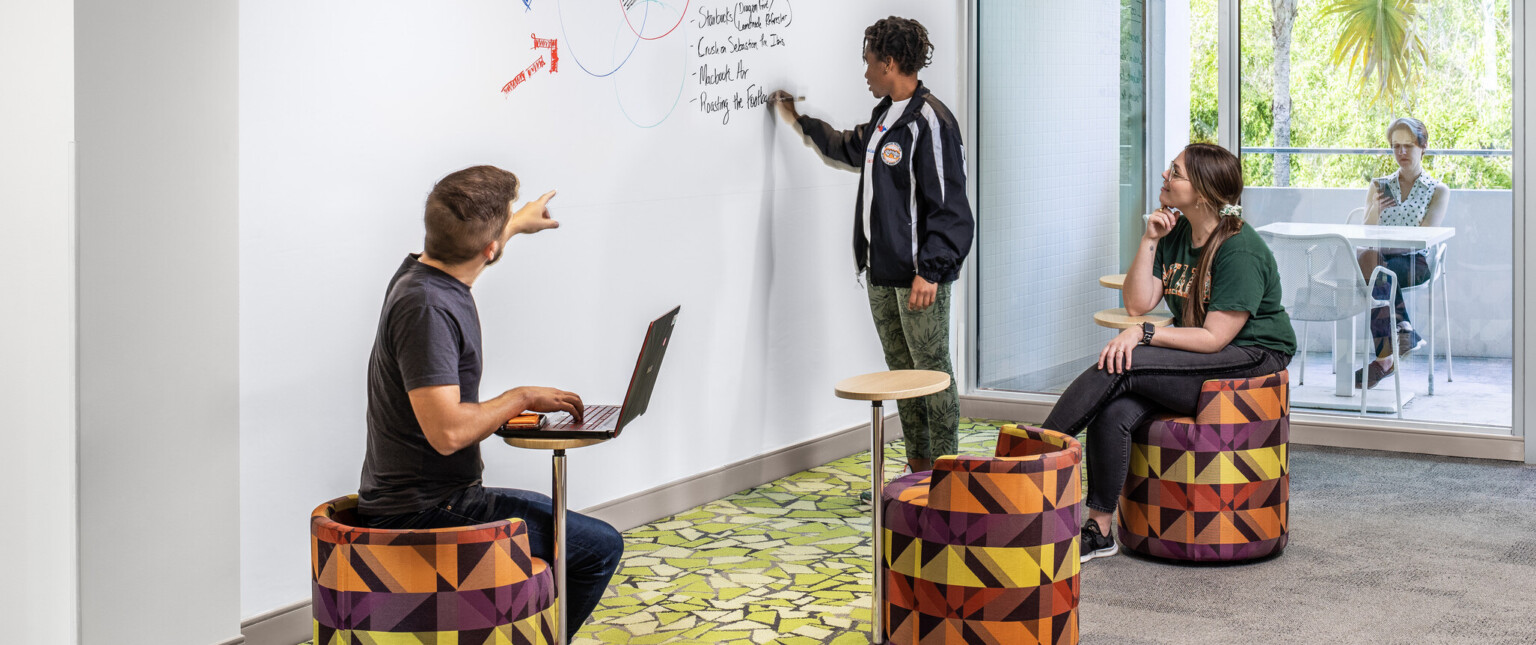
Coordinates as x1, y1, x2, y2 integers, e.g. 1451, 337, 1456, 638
841, 370, 949, 643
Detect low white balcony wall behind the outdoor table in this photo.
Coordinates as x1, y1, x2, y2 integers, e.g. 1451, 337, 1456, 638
1243, 187, 1514, 358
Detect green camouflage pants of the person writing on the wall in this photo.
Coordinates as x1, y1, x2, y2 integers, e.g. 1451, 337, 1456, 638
869, 283, 960, 461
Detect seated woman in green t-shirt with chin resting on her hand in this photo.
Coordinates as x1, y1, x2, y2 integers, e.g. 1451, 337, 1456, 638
1040, 143, 1296, 562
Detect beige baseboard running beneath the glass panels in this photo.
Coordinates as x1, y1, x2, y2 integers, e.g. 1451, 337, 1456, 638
960, 390, 1525, 461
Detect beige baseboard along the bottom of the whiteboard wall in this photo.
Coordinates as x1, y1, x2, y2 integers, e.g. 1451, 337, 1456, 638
238, 412, 902, 645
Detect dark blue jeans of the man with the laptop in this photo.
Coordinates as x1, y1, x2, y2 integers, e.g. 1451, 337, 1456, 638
361, 485, 624, 636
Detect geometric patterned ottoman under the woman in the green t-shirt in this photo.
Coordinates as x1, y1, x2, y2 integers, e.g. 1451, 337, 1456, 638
1118, 372, 1290, 562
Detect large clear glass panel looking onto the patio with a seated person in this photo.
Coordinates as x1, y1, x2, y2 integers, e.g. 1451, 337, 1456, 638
1234, 0, 1513, 433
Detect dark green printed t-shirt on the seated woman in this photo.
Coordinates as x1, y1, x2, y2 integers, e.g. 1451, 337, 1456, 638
1152, 218, 1296, 355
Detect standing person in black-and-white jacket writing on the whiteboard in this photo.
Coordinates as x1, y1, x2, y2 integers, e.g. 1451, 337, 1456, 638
771, 17, 975, 497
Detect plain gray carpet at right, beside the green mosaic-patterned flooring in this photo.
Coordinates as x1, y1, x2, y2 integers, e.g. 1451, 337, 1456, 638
1081, 445, 1536, 645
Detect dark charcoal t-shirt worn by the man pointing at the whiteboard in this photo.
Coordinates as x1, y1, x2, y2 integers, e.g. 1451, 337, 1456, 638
358, 255, 484, 516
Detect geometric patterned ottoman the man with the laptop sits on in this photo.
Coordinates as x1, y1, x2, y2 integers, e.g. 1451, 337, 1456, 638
310, 495, 556, 645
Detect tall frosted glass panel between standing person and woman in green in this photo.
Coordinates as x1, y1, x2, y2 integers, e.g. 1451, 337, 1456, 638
974, 0, 1120, 387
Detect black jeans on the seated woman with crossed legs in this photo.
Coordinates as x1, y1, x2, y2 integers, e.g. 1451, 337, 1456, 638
1040, 346, 1290, 513
